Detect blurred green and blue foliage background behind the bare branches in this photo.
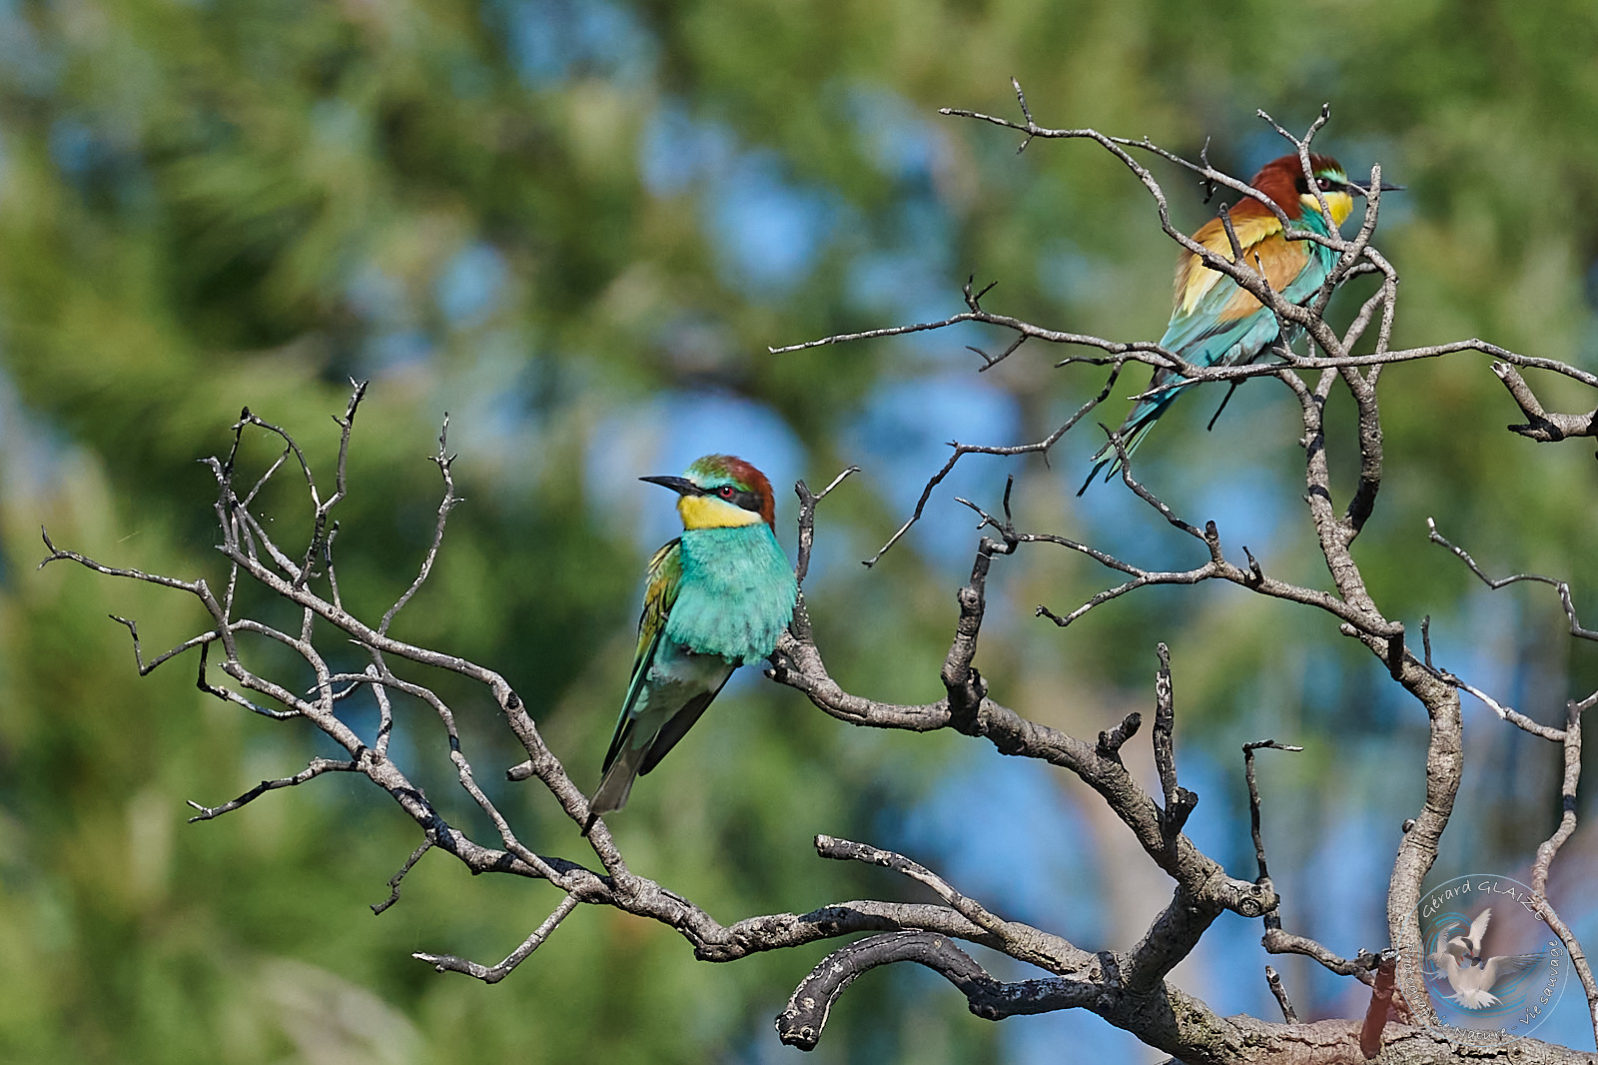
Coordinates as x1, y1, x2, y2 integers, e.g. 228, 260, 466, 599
0, 0, 1598, 1065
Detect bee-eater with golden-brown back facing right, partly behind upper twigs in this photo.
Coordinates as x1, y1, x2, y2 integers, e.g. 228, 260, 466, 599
1077, 155, 1398, 496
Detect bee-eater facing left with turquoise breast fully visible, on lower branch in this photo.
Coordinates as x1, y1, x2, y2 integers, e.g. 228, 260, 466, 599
583, 454, 799, 835
